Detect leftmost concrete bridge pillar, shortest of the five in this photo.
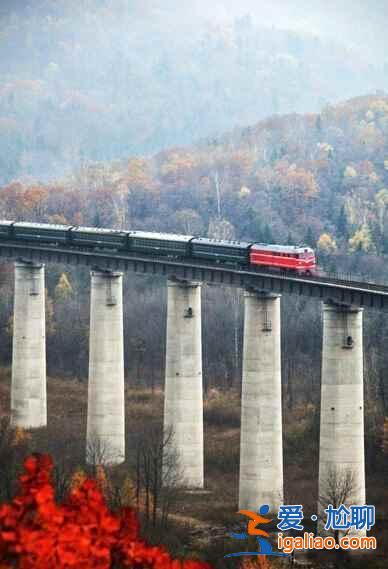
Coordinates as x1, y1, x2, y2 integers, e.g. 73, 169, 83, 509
11, 263, 47, 429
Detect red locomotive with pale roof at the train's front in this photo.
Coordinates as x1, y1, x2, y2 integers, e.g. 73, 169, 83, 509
249, 243, 316, 274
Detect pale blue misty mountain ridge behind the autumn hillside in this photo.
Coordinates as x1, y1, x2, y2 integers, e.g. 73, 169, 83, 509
0, 0, 388, 184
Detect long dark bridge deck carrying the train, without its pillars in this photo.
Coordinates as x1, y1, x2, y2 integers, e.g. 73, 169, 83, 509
0, 241, 388, 310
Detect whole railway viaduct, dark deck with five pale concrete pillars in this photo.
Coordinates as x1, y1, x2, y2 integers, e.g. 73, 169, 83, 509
0, 236, 388, 524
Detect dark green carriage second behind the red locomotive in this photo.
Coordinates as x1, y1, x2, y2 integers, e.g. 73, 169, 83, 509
128, 231, 193, 258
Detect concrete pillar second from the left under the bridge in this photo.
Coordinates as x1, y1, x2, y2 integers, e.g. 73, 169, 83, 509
86, 271, 125, 464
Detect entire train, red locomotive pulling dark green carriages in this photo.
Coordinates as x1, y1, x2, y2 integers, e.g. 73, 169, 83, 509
0, 220, 316, 274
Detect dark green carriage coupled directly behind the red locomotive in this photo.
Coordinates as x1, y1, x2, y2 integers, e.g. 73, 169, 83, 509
191, 237, 252, 265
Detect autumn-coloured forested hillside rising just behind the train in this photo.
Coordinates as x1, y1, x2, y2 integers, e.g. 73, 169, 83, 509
0, 96, 388, 260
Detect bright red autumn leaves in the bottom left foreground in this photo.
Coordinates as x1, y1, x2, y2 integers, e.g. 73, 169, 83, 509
0, 455, 210, 569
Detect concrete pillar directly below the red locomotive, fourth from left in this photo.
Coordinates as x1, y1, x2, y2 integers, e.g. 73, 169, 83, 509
239, 292, 283, 511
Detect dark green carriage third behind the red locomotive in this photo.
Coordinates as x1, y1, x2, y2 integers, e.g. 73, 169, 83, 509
68, 226, 129, 250
